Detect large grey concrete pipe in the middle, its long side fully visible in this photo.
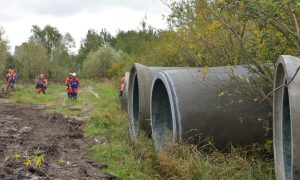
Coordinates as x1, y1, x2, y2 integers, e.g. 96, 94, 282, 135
151, 66, 272, 150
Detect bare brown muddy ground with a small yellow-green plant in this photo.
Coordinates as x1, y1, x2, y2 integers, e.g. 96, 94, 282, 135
0, 99, 115, 179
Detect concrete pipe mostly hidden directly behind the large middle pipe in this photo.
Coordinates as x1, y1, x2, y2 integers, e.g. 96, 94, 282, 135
128, 63, 177, 142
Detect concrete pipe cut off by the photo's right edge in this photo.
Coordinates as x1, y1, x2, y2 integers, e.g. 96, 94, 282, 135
273, 55, 300, 180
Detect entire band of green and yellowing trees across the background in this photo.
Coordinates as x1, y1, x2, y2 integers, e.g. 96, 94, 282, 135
0, 0, 300, 96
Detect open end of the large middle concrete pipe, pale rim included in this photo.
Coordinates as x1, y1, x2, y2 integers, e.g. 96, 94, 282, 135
150, 72, 180, 151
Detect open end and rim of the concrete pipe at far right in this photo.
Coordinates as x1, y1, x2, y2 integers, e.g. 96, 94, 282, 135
273, 56, 293, 179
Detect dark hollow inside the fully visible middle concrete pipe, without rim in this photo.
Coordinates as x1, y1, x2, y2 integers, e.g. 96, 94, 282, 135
151, 79, 173, 149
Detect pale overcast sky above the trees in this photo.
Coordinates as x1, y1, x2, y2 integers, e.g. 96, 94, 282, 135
0, 0, 170, 52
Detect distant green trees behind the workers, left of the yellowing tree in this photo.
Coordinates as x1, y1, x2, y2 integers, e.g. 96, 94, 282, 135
0, 21, 163, 80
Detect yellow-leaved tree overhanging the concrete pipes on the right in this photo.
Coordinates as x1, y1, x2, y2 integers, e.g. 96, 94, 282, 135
163, 0, 300, 101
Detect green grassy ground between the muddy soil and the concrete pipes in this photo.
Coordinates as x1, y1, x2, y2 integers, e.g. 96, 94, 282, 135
7, 80, 274, 180
